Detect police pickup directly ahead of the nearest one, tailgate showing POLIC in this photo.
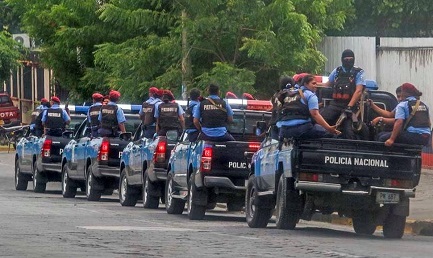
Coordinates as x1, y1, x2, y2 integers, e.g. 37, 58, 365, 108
165, 100, 272, 220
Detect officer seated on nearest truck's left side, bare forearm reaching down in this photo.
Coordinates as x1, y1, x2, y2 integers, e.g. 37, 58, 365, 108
277, 74, 340, 140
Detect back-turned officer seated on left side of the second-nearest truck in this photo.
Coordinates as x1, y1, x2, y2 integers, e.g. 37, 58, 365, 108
194, 84, 235, 141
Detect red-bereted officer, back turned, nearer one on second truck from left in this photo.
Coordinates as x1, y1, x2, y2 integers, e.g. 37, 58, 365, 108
98, 90, 126, 137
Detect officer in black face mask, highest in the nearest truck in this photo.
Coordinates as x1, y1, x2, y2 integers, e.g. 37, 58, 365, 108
320, 49, 365, 139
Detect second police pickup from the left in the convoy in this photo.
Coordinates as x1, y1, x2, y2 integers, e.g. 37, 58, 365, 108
61, 105, 141, 201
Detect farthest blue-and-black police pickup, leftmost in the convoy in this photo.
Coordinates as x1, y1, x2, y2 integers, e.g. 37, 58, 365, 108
15, 106, 88, 193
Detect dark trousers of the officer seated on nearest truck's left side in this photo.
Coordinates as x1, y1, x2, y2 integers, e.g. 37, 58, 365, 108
279, 122, 332, 140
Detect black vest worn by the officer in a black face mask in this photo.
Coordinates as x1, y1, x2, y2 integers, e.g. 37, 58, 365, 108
332, 66, 361, 103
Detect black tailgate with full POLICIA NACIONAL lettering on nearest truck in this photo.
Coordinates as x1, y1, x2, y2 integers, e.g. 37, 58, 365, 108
295, 139, 421, 179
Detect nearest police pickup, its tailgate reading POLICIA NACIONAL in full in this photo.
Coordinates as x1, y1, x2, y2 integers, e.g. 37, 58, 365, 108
246, 87, 422, 238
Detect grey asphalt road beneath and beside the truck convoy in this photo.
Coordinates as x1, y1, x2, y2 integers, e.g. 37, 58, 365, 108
0, 152, 433, 258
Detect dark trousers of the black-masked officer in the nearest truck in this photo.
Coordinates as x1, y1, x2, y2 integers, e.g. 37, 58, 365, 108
320, 102, 357, 139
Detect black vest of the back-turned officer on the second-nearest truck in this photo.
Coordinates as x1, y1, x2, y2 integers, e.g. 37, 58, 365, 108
200, 99, 227, 128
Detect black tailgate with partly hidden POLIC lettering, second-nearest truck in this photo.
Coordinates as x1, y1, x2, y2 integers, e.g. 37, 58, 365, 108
210, 141, 257, 178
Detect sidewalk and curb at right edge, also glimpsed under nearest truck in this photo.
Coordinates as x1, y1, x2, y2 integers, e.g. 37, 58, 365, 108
313, 169, 433, 236
